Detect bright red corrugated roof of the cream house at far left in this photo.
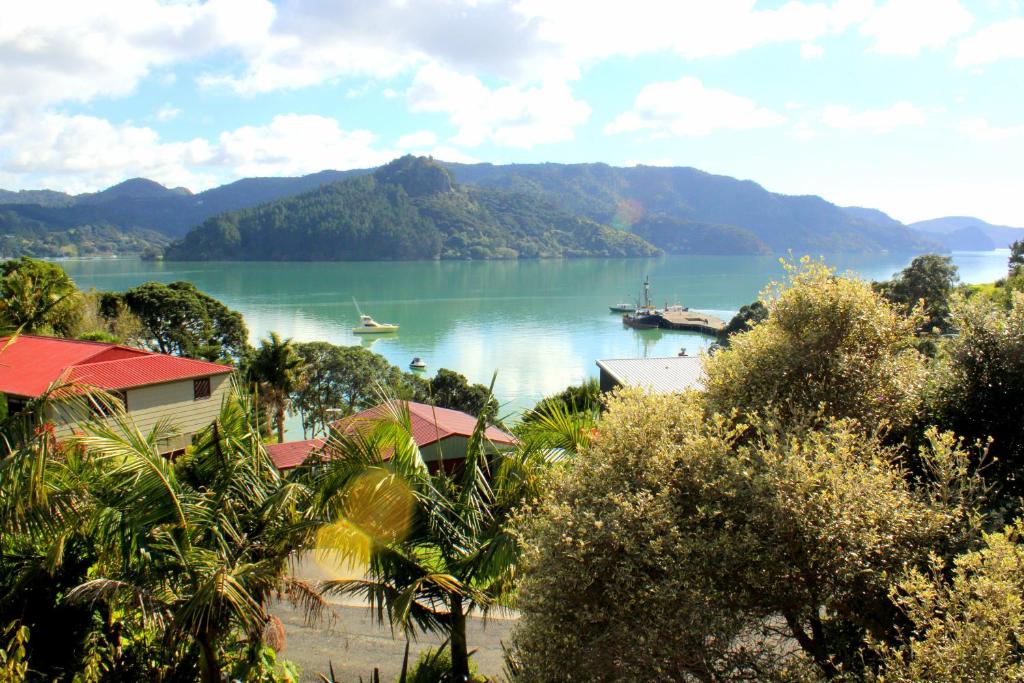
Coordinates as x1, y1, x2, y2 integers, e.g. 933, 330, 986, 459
0, 335, 232, 396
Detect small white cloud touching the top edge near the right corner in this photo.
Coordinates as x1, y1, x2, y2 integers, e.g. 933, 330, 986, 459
860, 0, 974, 55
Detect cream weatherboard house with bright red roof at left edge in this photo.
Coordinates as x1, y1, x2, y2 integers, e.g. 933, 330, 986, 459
0, 335, 233, 454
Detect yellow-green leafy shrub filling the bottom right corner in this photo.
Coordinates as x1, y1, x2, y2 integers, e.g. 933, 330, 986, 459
872, 521, 1024, 683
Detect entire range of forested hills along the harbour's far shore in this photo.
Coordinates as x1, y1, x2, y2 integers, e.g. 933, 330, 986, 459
0, 158, 1024, 259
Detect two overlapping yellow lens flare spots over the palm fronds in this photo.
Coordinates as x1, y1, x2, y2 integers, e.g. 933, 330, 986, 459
311, 470, 415, 580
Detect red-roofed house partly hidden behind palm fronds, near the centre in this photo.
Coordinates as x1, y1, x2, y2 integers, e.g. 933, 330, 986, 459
266, 400, 516, 472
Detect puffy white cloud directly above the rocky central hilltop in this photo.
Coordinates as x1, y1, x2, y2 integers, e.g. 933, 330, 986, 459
406, 65, 591, 147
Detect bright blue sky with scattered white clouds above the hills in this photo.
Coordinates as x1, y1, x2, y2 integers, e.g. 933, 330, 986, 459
0, 0, 1024, 226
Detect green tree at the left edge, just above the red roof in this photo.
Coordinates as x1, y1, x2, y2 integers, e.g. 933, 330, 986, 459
0, 256, 78, 336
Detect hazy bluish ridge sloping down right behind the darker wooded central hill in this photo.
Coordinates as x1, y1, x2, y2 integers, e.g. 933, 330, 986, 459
447, 164, 936, 254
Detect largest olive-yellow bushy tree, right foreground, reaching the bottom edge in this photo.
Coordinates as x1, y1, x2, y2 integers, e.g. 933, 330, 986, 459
513, 390, 980, 681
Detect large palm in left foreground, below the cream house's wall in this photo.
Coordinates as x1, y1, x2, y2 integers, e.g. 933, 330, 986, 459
58, 391, 323, 683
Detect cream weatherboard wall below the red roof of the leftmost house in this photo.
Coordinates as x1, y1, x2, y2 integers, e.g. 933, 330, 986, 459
53, 373, 230, 453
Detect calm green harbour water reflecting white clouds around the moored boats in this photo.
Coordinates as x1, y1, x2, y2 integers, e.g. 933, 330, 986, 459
62, 250, 1008, 436
